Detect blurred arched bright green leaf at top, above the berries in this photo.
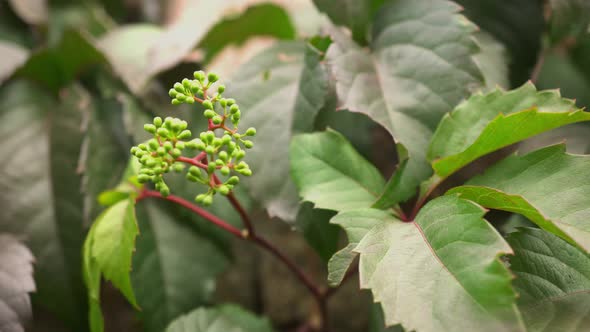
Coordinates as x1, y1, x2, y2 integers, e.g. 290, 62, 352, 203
198, 3, 295, 62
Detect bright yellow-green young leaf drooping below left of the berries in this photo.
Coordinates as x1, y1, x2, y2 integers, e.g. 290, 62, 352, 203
82, 195, 139, 332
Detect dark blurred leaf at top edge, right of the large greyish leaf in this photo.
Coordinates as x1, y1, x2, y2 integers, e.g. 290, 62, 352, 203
455, 0, 545, 87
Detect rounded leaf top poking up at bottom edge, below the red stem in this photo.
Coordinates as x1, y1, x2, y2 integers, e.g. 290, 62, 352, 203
166, 305, 273, 332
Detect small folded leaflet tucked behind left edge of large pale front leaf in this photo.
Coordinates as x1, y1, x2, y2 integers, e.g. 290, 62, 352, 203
328, 209, 390, 287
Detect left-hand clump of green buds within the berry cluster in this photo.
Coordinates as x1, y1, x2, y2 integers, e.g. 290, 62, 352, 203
131, 117, 195, 197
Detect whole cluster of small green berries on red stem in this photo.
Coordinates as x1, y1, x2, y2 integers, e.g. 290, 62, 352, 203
131, 71, 256, 205
